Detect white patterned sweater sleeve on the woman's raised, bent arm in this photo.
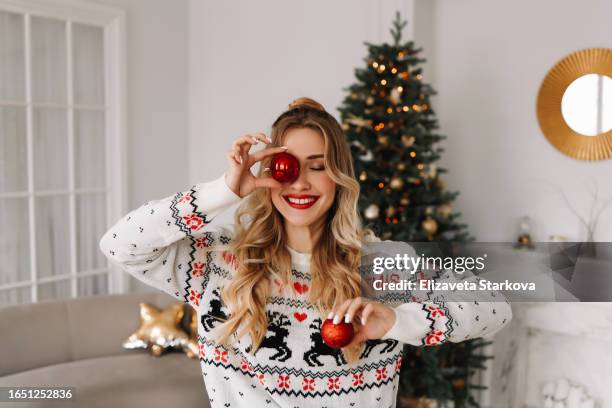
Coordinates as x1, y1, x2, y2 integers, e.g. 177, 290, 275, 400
100, 174, 240, 307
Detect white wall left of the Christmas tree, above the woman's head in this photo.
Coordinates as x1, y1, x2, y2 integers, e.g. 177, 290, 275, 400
189, 0, 413, 223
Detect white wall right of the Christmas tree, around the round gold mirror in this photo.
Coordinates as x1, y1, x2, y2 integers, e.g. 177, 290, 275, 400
415, 0, 612, 241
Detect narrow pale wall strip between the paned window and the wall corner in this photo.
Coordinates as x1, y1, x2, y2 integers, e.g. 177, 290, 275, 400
84, 0, 189, 209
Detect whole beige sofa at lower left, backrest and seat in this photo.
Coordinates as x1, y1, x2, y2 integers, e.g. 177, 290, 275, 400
0, 293, 210, 408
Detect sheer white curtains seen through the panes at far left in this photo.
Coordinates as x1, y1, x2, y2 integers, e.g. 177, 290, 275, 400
0, 11, 108, 306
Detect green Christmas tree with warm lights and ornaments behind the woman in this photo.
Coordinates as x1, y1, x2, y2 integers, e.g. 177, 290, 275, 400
339, 13, 491, 408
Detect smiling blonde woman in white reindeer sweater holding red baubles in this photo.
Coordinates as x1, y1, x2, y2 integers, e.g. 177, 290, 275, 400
100, 98, 512, 408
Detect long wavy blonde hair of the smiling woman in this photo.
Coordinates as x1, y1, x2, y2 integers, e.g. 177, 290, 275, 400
208, 98, 376, 363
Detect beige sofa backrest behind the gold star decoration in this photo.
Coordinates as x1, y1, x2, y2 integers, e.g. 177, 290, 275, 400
0, 292, 182, 376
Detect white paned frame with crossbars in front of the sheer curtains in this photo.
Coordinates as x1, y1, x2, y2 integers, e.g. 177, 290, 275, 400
0, 0, 128, 302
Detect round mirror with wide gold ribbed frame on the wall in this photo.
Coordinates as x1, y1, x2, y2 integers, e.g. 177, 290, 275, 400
537, 48, 612, 160
